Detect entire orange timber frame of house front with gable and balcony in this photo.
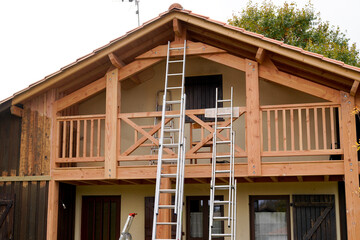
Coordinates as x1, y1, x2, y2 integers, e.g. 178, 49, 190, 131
0, 4, 360, 239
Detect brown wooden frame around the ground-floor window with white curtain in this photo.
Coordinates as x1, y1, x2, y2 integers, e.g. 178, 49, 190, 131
249, 195, 291, 240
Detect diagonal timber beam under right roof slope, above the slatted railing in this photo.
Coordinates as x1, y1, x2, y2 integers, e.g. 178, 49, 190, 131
259, 58, 340, 103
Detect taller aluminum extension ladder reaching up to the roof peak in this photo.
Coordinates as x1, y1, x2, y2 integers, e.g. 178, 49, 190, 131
152, 40, 186, 240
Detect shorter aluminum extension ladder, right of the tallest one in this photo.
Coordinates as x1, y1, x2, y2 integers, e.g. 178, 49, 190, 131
209, 87, 236, 240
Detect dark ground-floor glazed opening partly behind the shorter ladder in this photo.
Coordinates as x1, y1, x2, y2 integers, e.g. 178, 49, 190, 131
186, 196, 224, 240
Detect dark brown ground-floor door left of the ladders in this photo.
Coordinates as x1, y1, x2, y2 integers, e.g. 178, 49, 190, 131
81, 196, 121, 240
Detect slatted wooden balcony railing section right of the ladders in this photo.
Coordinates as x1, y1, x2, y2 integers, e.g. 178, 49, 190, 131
260, 103, 343, 157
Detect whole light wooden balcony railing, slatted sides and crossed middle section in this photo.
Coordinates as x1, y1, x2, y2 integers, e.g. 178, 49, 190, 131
55, 103, 343, 173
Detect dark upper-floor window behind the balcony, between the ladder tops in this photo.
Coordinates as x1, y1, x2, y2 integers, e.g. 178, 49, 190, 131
185, 75, 223, 122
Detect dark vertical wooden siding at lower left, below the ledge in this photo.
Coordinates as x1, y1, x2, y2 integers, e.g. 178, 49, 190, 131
0, 181, 48, 240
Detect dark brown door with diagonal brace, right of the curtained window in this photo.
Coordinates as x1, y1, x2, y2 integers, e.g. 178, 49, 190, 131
293, 195, 336, 240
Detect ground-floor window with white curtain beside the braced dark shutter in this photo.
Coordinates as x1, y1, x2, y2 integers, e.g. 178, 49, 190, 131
250, 196, 291, 240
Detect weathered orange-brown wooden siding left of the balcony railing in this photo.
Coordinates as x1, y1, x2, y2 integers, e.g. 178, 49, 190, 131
19, 91, 55, 176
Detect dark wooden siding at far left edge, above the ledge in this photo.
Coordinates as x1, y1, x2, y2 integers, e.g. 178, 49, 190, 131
0, 108, 21, 176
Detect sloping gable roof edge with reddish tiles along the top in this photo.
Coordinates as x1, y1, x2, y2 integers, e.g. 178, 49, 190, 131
6, 4, 360, 104
